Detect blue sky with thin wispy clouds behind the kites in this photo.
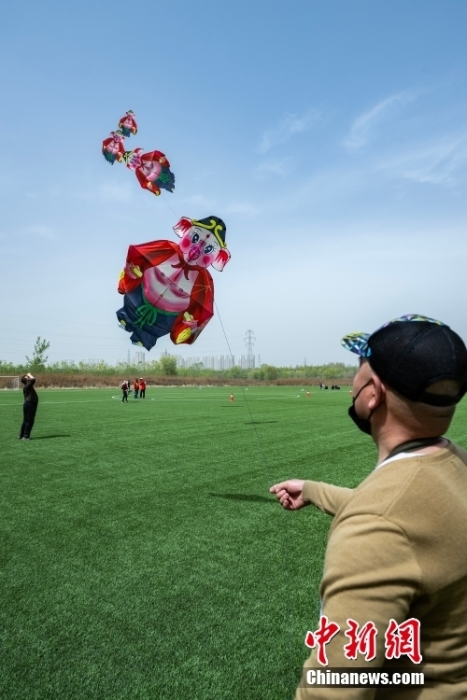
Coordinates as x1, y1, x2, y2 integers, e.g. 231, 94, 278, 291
0, 0, 467, 365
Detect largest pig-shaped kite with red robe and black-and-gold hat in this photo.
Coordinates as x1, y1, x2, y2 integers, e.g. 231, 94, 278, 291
117, 216, 230, 350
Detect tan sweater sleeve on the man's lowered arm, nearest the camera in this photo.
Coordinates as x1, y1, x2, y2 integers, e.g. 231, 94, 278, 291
296, 514, 421, 700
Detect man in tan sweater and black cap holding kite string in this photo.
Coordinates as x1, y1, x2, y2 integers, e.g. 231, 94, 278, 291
271, 315, 467, 700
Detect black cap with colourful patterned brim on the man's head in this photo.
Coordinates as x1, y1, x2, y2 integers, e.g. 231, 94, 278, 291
341, 314, 467, 406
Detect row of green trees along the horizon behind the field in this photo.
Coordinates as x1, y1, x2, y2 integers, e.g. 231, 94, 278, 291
0, 337, 357, 381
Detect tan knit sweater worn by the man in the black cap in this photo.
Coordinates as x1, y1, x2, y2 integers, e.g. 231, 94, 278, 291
296, 443, 467, 700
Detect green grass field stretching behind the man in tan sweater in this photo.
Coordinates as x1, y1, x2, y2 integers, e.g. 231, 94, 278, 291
0, 387, 467, 700
